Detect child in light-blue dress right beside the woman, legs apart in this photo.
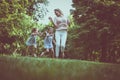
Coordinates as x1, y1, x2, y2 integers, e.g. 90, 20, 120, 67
40, 28, 55, 57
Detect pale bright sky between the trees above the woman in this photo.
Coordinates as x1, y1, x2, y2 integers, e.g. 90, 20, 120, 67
40, 0, 72, 24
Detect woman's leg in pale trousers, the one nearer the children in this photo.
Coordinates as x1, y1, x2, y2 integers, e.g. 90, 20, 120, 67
55, 31, 60, 58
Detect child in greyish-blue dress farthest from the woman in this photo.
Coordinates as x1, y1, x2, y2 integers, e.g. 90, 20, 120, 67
26, 28, 39, 57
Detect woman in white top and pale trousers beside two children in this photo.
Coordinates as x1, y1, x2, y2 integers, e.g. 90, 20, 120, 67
49, 9, 70, 58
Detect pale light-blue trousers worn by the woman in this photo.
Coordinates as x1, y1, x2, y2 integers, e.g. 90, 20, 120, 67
55, 30, 67, 57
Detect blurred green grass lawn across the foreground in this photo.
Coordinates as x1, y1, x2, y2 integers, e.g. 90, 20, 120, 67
0, 56, 120, 80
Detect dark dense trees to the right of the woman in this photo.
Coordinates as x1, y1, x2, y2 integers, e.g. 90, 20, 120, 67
68, 0, 120, 62
